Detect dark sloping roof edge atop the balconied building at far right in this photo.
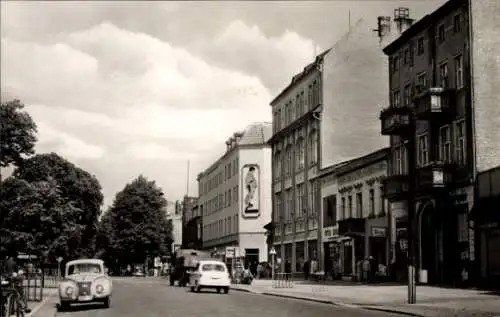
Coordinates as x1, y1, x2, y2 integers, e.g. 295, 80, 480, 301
383, 0, 467, 55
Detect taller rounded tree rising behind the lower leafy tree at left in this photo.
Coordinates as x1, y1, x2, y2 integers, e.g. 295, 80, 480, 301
13, 153, 104, 256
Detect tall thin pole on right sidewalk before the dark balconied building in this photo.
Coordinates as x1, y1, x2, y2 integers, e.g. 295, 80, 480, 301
407, 108, 417, 304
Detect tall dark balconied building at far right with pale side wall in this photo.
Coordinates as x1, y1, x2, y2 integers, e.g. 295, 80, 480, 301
380, 0, 500, 285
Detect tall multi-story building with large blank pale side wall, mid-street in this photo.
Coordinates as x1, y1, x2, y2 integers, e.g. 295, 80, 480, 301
271, 19, 394, 270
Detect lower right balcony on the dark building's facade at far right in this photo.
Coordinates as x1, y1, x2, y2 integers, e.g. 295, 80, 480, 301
417, 162, 455, 192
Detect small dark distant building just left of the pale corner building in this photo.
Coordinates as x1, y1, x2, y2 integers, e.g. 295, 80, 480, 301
182, 201, 203, 250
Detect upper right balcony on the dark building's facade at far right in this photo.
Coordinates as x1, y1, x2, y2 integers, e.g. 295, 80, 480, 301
414, 88, 454, 120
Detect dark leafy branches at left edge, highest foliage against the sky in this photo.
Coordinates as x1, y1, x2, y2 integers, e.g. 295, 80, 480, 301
0, 99, 37, 167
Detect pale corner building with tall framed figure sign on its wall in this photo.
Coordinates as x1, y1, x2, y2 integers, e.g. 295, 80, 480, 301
197, 123, 272, 265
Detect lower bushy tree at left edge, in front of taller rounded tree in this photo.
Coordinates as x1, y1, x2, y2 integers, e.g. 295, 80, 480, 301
0, 177, 84, 259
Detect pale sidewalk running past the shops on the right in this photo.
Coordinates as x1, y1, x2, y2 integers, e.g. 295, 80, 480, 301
232, 280, 500, 317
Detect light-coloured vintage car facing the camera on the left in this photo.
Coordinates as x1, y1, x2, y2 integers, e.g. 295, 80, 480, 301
59, 259, 113, 310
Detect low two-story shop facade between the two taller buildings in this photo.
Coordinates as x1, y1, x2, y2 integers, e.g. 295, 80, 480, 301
321, 148, 391, 278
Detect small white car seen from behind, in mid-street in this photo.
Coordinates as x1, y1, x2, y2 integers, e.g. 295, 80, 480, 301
189, 260, 231, 294
